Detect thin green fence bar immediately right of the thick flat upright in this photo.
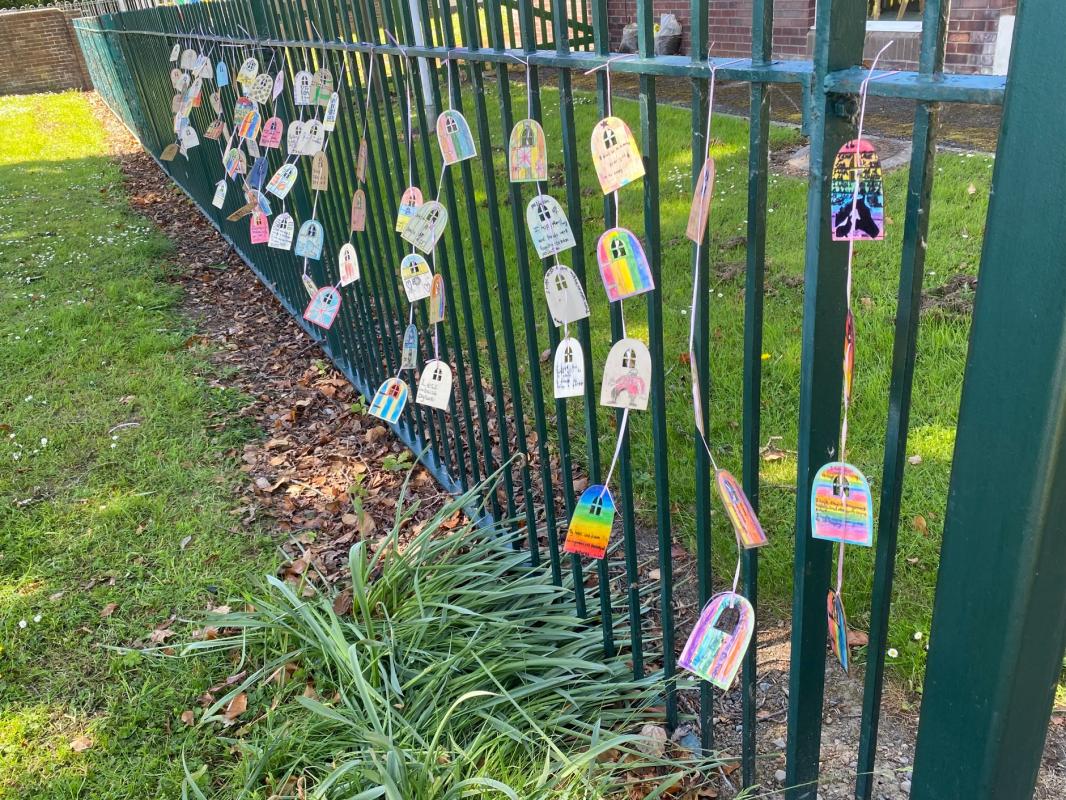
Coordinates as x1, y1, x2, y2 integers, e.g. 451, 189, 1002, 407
855, 0, 950, 800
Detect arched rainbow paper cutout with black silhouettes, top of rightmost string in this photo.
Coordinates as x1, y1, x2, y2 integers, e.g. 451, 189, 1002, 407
829, 139, 885, 242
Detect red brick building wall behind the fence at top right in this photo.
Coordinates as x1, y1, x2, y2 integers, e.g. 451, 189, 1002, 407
608, 0, 1018, 73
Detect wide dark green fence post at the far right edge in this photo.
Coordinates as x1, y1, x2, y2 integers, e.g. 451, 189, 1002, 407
912, 0, 1066, 800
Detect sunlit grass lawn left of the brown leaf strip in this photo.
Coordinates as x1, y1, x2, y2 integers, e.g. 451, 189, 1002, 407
0, 94, 279, 800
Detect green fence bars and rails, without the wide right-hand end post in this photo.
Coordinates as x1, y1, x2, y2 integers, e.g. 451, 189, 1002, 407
76, 0, 1057, 800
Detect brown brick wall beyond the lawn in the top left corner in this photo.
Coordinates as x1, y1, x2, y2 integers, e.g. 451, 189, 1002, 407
0, 9, 93, 95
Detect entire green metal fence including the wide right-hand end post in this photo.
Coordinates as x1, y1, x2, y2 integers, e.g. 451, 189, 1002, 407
77, 0, 1066, 800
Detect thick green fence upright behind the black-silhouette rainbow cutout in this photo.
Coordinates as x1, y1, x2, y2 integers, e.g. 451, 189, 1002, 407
786, 0, 866, 800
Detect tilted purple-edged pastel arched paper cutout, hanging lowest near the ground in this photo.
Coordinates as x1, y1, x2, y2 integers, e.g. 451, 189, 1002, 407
677, 592, 755, 691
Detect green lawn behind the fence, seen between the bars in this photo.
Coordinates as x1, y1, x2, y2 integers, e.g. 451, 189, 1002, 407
381, 76, 980, 686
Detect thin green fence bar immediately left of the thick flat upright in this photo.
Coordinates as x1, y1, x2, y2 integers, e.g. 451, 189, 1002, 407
741, 0, 774, 786
